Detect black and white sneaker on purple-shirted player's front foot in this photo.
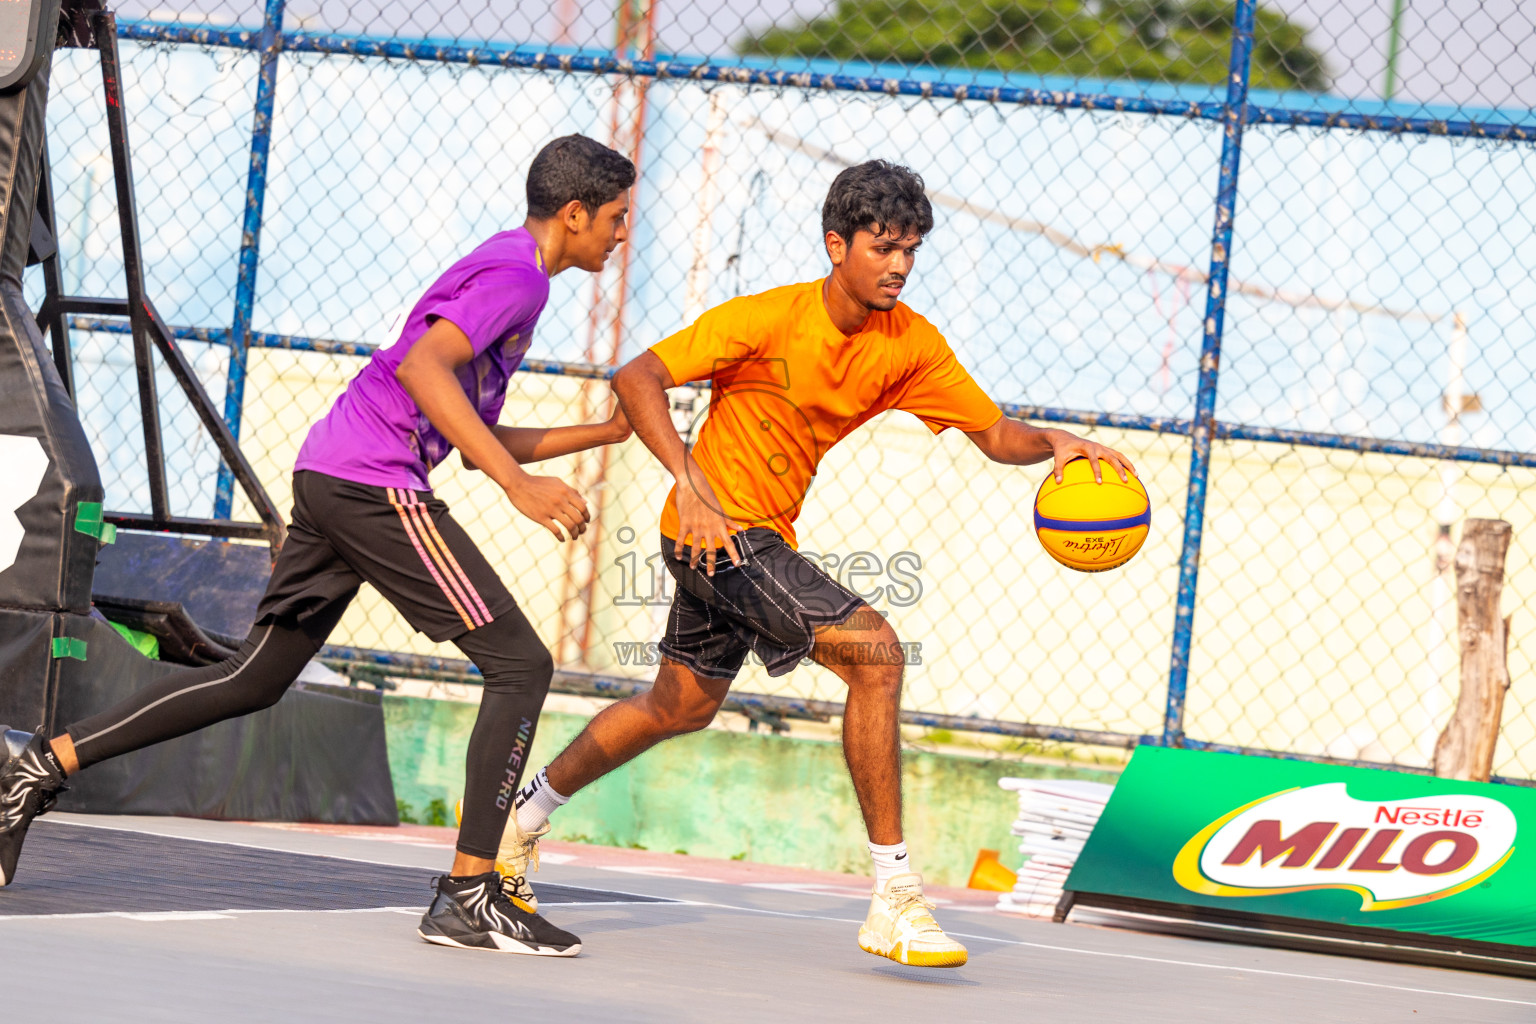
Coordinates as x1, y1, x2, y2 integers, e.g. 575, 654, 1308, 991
416, 870, 581, 956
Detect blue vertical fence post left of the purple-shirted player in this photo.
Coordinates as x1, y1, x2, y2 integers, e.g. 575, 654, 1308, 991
214, 0, 286, 519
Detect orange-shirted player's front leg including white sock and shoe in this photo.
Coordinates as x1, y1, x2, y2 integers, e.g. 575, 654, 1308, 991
811, 605, 966, 967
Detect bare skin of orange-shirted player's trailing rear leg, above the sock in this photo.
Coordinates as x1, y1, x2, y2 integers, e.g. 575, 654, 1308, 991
544, 659, 731, 797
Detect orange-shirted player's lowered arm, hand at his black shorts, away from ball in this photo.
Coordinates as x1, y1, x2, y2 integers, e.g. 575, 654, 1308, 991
613, 350, 742, 576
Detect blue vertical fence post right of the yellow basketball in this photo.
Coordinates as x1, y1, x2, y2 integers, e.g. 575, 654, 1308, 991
1163, 0, 1256, 746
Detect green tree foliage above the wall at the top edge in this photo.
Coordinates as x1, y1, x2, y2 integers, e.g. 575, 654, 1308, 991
737, 0, 1329, 92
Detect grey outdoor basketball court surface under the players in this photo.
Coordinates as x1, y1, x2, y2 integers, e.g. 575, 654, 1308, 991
0, 814, 1536, 1024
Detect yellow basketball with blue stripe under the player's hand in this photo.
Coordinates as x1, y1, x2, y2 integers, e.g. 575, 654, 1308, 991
1035, 457, 1152, 573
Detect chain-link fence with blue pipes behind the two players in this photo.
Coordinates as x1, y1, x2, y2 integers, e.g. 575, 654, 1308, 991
31, 0, 1536, 778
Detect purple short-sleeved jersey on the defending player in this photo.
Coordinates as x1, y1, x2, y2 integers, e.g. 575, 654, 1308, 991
293, 227, 550, 491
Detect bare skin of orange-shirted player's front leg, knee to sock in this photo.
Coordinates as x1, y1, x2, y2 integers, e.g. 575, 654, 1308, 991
811, 605, 902, 846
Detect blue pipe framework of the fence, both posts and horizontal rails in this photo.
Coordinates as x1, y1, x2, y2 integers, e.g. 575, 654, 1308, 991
69, 8, 1536, 781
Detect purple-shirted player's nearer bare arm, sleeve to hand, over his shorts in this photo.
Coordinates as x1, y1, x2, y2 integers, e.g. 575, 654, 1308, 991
395, 319, 591, 540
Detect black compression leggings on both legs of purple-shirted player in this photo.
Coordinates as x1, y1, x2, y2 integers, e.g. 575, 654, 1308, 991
66, 600, 554, 858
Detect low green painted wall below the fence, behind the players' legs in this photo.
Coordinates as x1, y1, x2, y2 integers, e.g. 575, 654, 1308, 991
384, 697, 1117, 886
